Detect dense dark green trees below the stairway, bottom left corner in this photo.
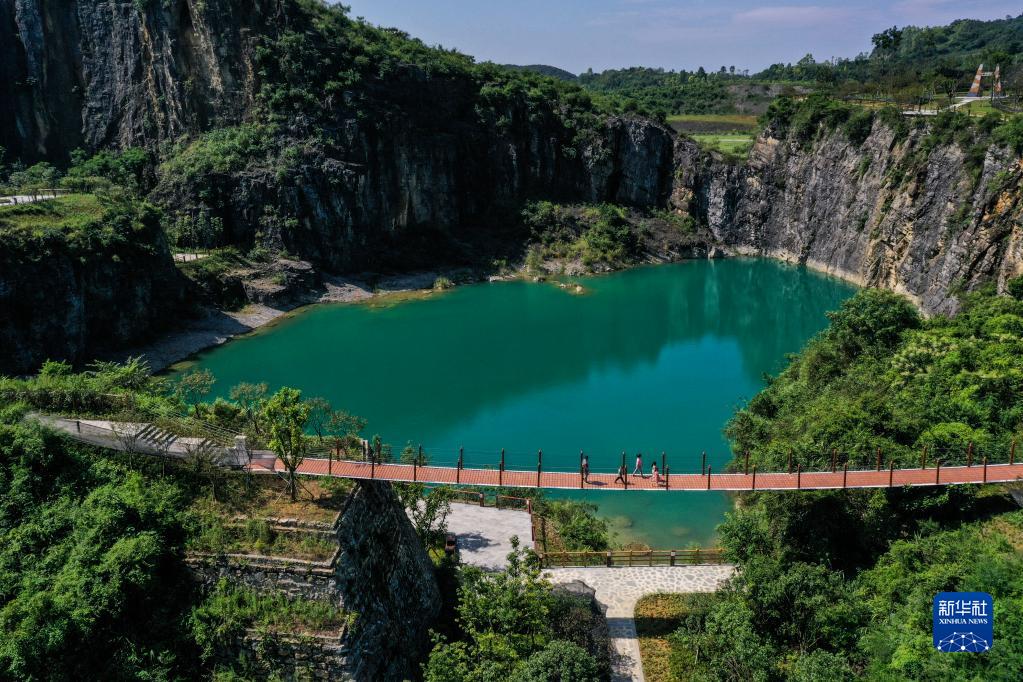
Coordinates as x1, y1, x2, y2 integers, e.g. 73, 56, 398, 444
0, 417, 197, 680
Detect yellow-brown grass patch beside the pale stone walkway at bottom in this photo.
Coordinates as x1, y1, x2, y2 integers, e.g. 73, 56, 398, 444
634, 593, 717, 682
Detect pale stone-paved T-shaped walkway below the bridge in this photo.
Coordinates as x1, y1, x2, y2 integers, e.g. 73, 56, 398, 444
544, 565, 735, 682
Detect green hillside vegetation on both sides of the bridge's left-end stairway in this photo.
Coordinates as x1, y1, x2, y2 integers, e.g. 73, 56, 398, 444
0, 361, 376, 680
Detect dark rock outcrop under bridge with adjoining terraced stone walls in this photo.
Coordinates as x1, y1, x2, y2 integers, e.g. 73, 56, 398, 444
187, 482, 441, 680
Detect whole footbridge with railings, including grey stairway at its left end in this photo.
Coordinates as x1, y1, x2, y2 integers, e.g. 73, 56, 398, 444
37, 415, 1023, 492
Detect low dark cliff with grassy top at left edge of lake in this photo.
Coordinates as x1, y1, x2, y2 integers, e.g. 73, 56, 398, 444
0, 196, 185, 374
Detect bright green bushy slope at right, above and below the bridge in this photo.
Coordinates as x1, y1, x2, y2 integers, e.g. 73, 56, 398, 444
654, 284, 1023, 680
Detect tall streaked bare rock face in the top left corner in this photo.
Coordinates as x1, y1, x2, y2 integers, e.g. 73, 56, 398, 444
0, 0, 276, 162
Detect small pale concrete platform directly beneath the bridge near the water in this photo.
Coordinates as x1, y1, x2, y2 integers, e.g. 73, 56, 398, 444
447, 502, 532, 571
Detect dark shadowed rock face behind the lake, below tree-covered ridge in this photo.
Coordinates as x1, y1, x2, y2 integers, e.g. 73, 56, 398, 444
155, 111, 674, 271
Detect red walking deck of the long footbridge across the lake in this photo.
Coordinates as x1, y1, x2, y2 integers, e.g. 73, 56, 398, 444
250, 458, 1023, 491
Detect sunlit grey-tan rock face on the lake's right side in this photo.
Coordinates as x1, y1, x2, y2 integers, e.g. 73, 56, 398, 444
672, 122, 1023, 313
